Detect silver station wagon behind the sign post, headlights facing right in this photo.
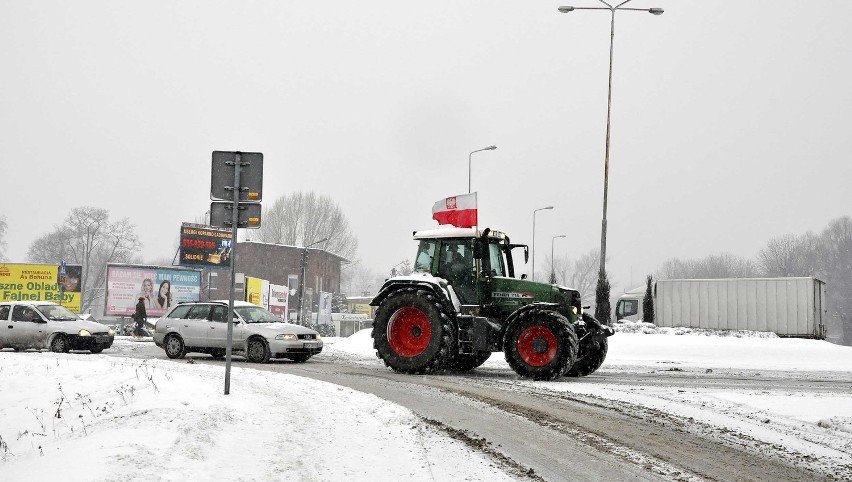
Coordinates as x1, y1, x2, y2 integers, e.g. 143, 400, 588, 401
154, 301, 323, 363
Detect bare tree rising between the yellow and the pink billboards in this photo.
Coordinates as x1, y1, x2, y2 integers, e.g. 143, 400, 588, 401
27, 206, 142, 311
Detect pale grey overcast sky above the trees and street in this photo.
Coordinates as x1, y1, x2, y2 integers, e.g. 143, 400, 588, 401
0, 0, 852, 292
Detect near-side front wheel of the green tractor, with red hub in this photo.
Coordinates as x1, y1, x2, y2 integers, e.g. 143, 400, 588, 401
503, 309, 577, 380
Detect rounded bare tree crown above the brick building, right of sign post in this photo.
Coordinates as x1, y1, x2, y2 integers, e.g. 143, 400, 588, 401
254, 192, 358, 259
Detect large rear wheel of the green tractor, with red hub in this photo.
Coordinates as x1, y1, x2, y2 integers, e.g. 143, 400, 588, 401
372, 288, 456, 374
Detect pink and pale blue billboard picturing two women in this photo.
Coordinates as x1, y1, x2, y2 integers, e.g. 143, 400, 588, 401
104, 264, 201, 318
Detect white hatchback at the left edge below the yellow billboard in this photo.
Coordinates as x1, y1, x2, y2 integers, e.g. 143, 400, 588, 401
0, 301, 115, 353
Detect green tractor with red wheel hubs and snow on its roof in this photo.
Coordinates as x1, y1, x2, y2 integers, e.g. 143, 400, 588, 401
370, 228, 613, 380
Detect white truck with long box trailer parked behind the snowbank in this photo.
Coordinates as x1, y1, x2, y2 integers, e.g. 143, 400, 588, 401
615, 278, 826, 339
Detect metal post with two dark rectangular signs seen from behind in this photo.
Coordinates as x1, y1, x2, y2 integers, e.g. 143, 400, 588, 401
210, 151, 263, 395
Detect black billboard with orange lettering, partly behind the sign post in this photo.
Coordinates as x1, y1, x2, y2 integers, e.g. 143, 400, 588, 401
180, 223, 232, 268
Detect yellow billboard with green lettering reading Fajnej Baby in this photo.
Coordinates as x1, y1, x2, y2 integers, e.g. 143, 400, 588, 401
0, 263, 83, 313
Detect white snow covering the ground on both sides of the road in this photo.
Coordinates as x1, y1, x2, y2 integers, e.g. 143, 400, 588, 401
0, 330, 852, 481
